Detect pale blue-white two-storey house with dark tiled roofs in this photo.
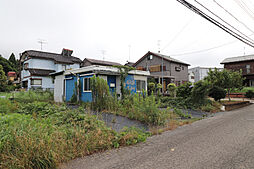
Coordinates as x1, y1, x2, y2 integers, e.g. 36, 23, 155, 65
20, 49, 82, 90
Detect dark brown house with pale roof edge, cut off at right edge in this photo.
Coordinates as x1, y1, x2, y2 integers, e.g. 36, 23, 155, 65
221, 55, 254, 86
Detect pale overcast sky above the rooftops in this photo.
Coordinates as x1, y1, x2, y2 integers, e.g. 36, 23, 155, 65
0, 0, 254, 67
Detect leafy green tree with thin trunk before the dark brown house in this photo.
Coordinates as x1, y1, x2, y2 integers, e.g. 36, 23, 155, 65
205, 69, 244, 100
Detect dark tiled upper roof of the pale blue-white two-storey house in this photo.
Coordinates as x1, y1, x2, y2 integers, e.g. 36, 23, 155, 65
21, 50, 82, 64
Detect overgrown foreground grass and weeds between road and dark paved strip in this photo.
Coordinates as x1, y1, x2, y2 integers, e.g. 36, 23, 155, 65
0, 102, 149, 169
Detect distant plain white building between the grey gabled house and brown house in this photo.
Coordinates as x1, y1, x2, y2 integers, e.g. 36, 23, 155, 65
188, 66, 223, 83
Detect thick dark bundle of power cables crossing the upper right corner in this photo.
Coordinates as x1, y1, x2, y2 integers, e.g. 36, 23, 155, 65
177, 0, 254, 48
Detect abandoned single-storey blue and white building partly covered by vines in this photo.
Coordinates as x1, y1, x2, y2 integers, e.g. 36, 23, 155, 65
51, 65, 150, 102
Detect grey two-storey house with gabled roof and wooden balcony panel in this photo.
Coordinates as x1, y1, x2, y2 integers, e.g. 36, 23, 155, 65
133, 51, 190, 92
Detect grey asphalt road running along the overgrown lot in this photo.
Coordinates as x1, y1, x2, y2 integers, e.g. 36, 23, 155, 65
61, 105, 254, 169
